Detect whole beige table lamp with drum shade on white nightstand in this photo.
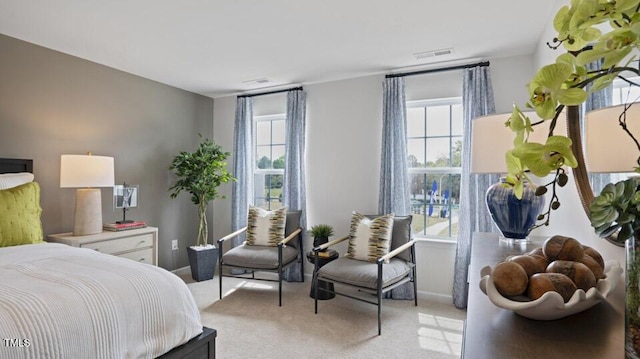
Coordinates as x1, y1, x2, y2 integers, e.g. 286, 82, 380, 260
60, 153, 114, 236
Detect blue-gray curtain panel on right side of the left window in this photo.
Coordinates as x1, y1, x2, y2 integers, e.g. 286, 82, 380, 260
282, 89, 307, 282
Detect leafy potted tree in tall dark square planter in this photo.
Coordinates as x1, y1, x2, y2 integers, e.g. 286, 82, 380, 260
169, 136, 235, 281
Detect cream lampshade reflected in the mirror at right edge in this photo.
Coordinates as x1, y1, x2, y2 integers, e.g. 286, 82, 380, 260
585, 102, 640, 173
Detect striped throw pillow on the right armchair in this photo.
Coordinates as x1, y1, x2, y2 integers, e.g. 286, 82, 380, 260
345, 212, 393, 262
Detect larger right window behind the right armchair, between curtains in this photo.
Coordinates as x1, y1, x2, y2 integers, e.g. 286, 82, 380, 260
407, 97, 462, 239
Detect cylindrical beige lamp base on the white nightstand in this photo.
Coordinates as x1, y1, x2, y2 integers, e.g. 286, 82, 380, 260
73, 188, 102, 236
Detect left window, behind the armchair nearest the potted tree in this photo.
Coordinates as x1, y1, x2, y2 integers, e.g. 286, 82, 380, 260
253, 114, 286, 210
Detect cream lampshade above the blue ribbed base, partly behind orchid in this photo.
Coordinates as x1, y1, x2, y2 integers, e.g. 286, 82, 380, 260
471, 111, 567, 173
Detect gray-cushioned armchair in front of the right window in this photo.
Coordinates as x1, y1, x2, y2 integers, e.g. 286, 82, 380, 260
313, 216, 418, 335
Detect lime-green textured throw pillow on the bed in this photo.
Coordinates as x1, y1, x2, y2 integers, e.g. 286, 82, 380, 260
0, 182, 42, 247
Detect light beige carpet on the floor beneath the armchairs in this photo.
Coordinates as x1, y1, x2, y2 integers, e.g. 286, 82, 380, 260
182, 275, 466, 359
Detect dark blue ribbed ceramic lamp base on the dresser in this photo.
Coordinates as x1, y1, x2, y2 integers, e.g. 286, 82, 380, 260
486, 178, 545, 243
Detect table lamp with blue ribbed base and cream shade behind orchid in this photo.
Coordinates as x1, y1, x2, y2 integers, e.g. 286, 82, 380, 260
471, 112, 567, 242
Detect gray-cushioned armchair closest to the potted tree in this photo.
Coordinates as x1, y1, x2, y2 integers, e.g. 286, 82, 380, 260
218, 211, 304, 306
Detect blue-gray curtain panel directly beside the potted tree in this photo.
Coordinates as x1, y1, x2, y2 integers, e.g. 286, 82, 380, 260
231, 97, 254, 247
